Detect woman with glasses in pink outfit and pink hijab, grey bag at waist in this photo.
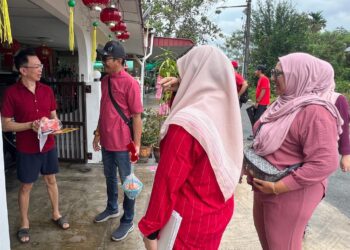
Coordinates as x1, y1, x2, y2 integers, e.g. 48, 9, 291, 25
253, 53, 343, 250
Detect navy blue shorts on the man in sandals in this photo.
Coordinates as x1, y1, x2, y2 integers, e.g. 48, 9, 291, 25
16, 148, 58, 183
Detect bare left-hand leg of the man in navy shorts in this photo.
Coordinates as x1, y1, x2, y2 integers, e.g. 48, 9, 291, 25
18, 183, 33, 242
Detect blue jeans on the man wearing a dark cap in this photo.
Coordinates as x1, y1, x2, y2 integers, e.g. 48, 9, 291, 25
102, 148, 135, 223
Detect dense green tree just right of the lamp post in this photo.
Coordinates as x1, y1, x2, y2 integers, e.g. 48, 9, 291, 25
251, 0, 310, 72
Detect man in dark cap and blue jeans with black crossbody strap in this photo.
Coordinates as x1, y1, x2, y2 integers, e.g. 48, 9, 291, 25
93, 41, 143, 241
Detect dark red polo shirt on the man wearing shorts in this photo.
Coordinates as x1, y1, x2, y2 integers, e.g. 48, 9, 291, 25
1, 82, 56, 153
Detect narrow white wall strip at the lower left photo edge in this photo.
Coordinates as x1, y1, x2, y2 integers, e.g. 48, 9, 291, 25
0, 118, 11, 250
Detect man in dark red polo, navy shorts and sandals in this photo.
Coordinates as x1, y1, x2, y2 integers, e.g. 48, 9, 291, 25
1, 49, 69, 243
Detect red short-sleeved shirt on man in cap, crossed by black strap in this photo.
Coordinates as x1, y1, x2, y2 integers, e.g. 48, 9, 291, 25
98, 70, 143, 151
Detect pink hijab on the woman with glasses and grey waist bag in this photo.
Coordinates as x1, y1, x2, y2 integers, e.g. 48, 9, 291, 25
253, 53, 343, 156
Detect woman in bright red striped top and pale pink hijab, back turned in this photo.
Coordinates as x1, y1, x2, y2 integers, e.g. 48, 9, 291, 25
139, 46, 243, 250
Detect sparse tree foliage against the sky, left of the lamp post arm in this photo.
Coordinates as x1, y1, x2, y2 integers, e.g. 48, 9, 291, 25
143, 0, 222, 43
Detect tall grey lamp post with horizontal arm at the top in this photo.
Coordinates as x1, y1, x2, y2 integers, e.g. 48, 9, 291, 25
216, 0, 252, 79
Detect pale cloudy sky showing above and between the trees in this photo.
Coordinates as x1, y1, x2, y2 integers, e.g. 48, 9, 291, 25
209, 0, 350, 39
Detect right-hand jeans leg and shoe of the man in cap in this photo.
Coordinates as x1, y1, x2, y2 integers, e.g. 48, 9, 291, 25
112, 151, 135, 241
